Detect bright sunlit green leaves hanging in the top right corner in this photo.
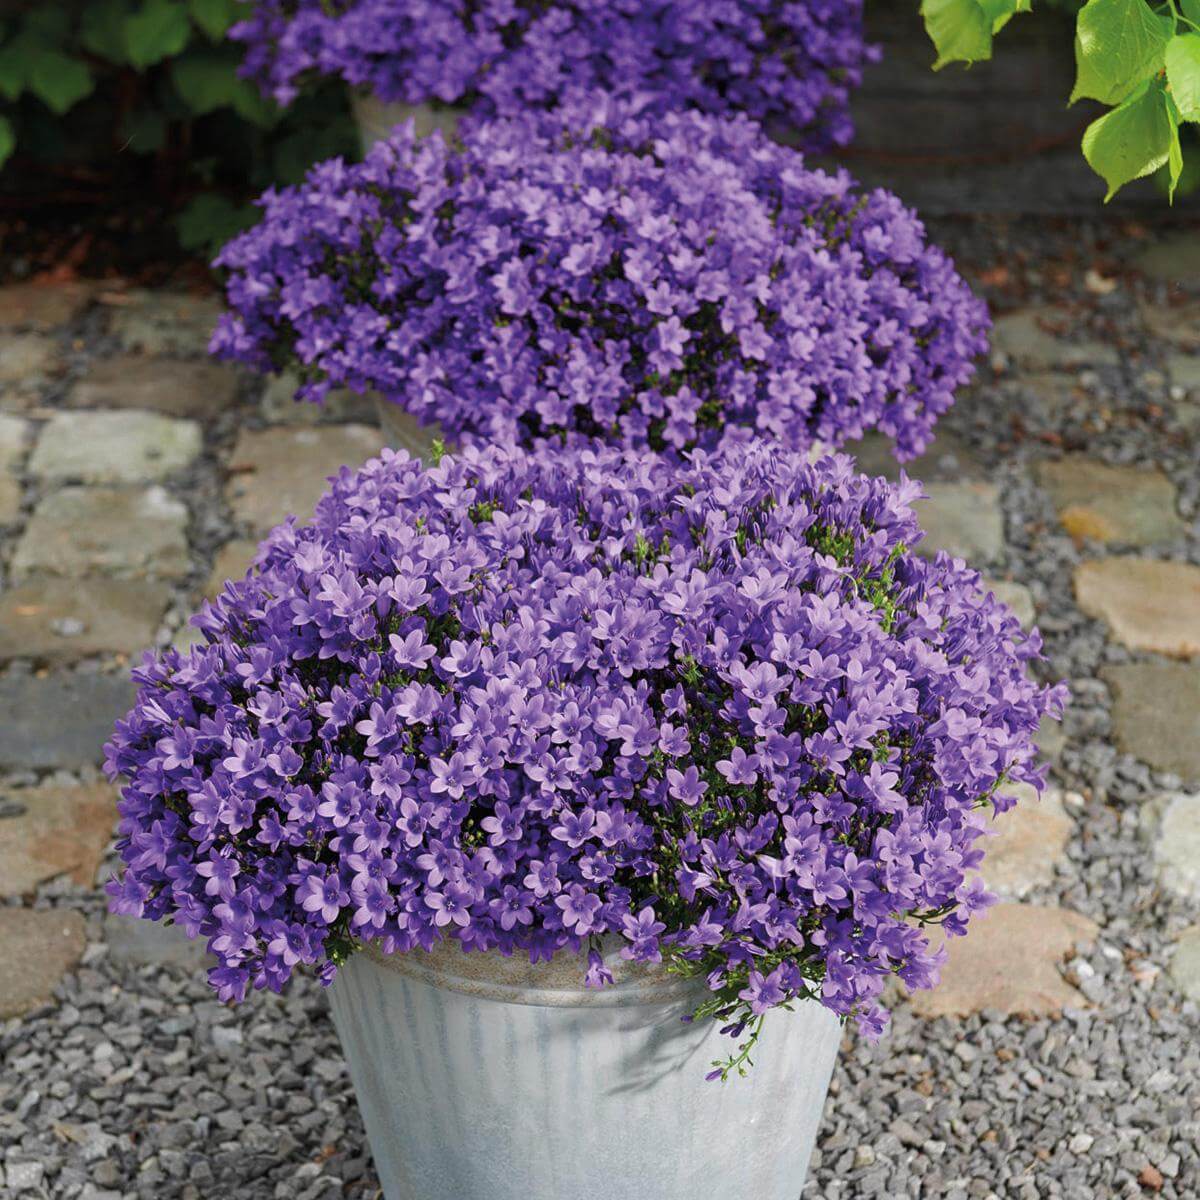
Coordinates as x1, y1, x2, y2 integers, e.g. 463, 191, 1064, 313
920, 0, 1200, 200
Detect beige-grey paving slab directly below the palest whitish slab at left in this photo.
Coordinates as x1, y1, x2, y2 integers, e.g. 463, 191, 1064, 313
12, 486, 191, 580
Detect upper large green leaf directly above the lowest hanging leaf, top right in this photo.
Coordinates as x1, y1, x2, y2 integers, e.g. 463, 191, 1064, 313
1070, 0, 1174, 104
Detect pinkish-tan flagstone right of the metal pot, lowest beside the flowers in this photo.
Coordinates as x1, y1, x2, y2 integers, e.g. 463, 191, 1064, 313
912, 901, 1099, 1016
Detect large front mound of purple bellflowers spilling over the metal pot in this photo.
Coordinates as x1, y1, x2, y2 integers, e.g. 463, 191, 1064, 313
106, 443, 1063, 1033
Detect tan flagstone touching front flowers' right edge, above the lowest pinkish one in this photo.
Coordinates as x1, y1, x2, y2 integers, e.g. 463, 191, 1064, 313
977, 784, 1078, 899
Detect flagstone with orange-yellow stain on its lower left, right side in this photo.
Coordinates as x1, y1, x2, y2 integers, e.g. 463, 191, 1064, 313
1037, 455, 1187, 546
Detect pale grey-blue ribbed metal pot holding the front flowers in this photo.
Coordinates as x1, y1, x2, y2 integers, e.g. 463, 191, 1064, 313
329, 943, 841, 1200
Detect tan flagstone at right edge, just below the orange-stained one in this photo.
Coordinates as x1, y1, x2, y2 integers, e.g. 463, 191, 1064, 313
1075, 556, 1200, 658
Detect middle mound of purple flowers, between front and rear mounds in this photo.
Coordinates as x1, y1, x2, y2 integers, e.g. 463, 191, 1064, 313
212, 106, 988, 458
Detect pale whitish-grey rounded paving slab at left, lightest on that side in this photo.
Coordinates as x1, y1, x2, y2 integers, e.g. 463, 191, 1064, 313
29, 409, 203, 484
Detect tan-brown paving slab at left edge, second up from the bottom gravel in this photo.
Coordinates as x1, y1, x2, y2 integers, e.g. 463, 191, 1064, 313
0, 784, 118, 898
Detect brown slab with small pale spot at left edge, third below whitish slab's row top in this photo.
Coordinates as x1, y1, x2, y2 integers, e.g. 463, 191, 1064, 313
0, 577, 170, 664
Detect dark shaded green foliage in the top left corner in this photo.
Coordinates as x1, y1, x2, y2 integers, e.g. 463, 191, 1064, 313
0, 0, 356, 254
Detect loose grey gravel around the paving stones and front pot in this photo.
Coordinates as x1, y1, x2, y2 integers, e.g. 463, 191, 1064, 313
0, 222, 1200, 1200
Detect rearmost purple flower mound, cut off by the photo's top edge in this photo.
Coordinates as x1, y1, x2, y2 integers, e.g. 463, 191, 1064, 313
232, 0, 874, 149
